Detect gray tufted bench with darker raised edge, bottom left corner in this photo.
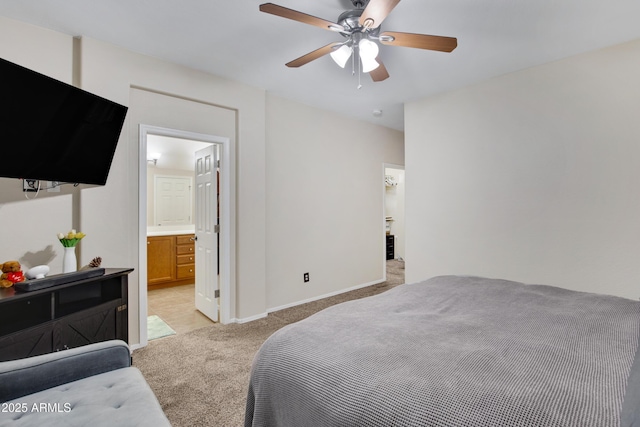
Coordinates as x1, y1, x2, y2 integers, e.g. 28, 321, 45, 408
0, 340, 170, 427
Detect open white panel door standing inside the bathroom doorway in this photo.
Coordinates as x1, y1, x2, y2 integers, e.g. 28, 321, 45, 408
194, 144, 218, 322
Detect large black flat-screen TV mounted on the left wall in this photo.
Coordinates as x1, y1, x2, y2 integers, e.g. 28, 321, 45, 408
0, 58, 127, 185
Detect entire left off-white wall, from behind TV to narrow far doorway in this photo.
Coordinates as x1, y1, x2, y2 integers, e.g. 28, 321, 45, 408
0, 17, 404, 344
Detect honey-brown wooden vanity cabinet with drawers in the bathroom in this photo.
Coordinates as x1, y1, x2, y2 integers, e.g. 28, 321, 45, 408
147, 234, 196, 289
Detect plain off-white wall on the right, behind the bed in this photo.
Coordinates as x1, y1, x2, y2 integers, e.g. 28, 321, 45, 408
405, 41, 640, 299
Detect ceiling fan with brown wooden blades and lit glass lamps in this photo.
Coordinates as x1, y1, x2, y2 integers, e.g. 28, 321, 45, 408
260, 0, 458, 82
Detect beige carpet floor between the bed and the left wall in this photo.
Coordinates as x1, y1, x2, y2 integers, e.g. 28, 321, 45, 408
133, 260, 404, 427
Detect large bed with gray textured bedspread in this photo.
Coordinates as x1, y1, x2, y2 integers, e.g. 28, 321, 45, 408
245, 276, 640, 427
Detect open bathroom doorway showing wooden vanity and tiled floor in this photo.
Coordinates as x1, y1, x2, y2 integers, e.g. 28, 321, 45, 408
147, 134, 219, 339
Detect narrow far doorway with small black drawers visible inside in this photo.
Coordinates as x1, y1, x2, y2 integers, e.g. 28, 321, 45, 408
383, 164, 405, 278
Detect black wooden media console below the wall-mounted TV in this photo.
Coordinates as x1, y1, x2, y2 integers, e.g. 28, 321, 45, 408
0, 268, 133, 361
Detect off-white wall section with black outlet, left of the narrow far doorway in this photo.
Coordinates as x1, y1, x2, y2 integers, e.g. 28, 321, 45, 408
266, 94, 404, 309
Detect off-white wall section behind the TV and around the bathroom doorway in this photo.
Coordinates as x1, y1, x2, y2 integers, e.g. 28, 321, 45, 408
0, 18, 266, 344
